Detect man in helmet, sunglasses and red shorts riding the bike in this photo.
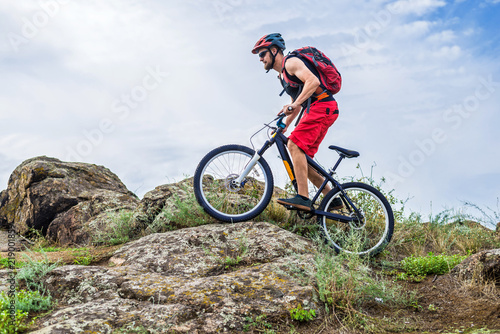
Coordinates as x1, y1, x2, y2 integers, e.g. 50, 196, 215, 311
252, 33, 339, 211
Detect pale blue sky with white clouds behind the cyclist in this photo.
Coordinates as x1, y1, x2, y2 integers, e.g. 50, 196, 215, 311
0, 0, 500, 227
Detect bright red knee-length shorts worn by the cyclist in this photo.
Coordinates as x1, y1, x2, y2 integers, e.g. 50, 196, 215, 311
288, 101, 339, 158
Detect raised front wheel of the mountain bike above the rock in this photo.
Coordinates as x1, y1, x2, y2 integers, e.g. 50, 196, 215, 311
194, 145, 274, 223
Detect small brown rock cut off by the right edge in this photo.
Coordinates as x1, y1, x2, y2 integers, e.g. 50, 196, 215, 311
451, 249, 500, 283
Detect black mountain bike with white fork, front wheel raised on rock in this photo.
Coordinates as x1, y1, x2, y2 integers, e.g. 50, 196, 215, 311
194, 114, 394, 256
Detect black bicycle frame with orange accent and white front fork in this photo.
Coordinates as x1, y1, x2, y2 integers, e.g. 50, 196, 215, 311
233, 116, 360, 223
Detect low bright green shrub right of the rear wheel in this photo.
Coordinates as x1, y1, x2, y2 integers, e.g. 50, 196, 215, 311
401, 253, 467, 276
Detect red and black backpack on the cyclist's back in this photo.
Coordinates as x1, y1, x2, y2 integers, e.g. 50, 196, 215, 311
282, 46, 342, 94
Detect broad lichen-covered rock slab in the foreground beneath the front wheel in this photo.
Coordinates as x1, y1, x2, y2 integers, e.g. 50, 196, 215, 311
34, 222, 321, 333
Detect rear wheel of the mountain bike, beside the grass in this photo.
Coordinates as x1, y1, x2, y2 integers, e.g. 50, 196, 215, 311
319, 182, 394, 256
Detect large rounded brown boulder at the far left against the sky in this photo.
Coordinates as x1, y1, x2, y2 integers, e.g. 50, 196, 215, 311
0, 157, 139, 244
